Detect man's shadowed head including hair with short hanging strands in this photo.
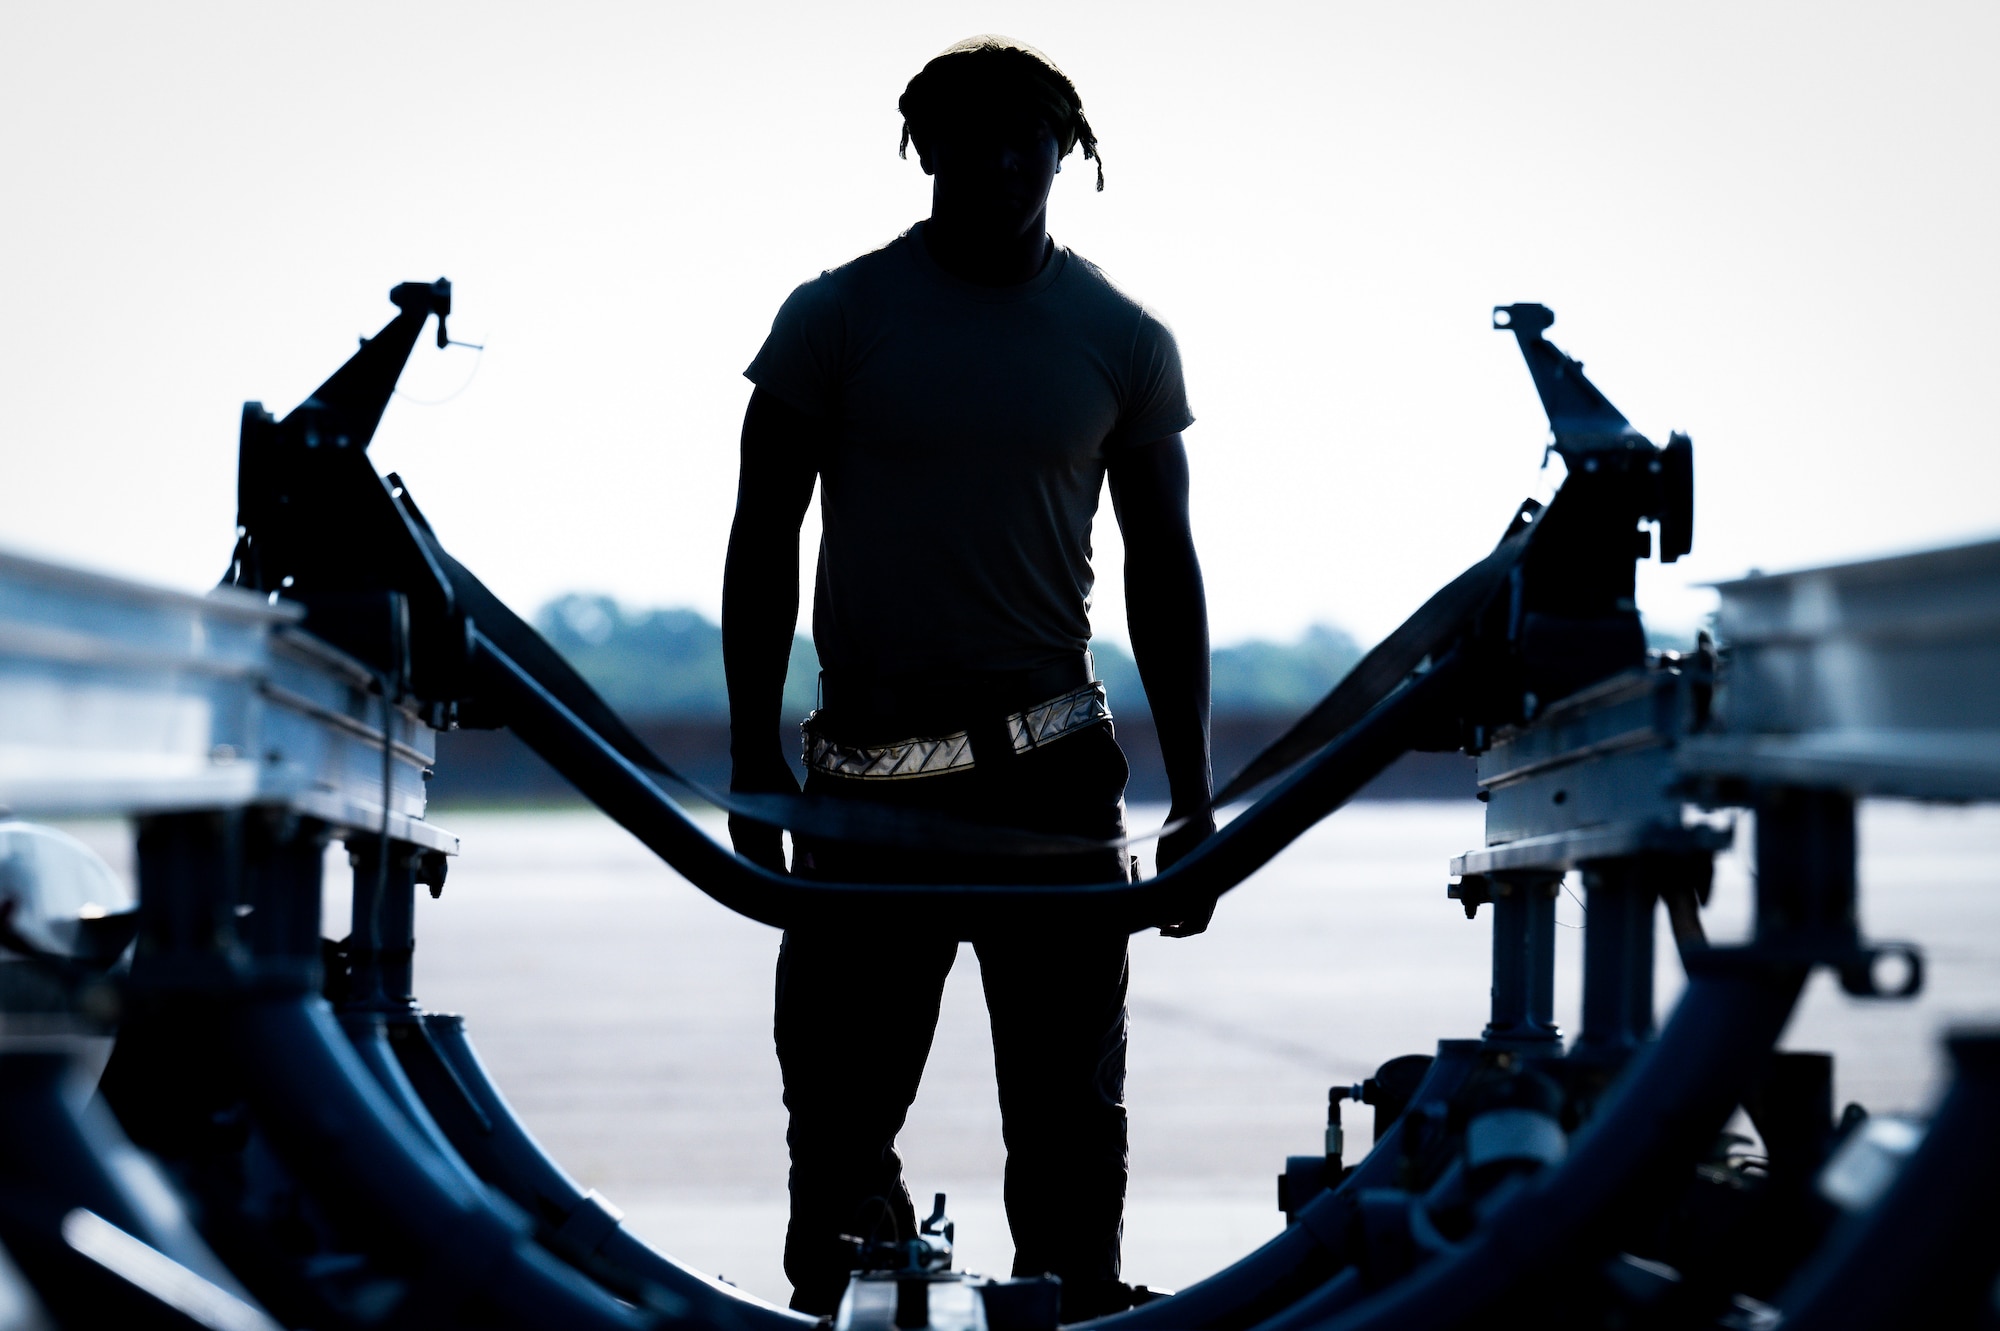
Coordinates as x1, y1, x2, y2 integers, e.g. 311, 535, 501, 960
896, 34, 1104, 238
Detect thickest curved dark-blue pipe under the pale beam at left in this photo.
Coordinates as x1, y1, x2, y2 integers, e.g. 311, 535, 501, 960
104, 809, 654, 1331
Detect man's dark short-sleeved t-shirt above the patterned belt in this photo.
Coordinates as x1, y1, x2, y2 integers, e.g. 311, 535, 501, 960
744, 224, 1194, 675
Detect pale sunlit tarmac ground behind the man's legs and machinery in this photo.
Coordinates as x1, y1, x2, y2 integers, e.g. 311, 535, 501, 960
344, 801, 2000, 1303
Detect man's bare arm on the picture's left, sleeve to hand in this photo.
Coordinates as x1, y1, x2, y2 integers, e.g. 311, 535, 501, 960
722, 388, 820, 873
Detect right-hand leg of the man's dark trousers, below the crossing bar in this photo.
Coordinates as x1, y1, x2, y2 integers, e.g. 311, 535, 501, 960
978, 935, 1128, 1321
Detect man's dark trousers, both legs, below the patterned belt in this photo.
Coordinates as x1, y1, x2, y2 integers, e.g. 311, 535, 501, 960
774, 725, 1128, 1321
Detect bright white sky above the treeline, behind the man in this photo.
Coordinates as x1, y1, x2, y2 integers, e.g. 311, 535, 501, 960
0, 0, 2000, 642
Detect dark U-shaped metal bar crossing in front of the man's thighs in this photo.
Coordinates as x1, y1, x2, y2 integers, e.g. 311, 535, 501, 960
470, 630, 1462, 937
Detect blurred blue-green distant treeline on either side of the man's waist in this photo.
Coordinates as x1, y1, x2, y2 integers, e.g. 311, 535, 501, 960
536, 594, 1362, 719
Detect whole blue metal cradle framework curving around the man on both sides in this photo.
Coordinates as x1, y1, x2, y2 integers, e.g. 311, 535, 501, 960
0, 280, 2000, 1331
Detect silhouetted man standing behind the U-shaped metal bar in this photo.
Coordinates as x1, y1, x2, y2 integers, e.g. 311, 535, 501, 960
722, 36, 1214, 1321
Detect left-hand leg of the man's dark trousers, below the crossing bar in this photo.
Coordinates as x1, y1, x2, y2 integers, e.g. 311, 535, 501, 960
774, 931, 958, 1315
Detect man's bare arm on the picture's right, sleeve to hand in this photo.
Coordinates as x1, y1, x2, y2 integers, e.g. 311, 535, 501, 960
1108, 434, 1216, 869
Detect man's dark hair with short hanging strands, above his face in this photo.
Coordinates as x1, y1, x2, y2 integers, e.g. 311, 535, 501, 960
896, 32, 1104, 190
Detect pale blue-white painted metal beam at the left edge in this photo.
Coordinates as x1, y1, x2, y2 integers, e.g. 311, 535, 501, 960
0, 554, 458, 853
